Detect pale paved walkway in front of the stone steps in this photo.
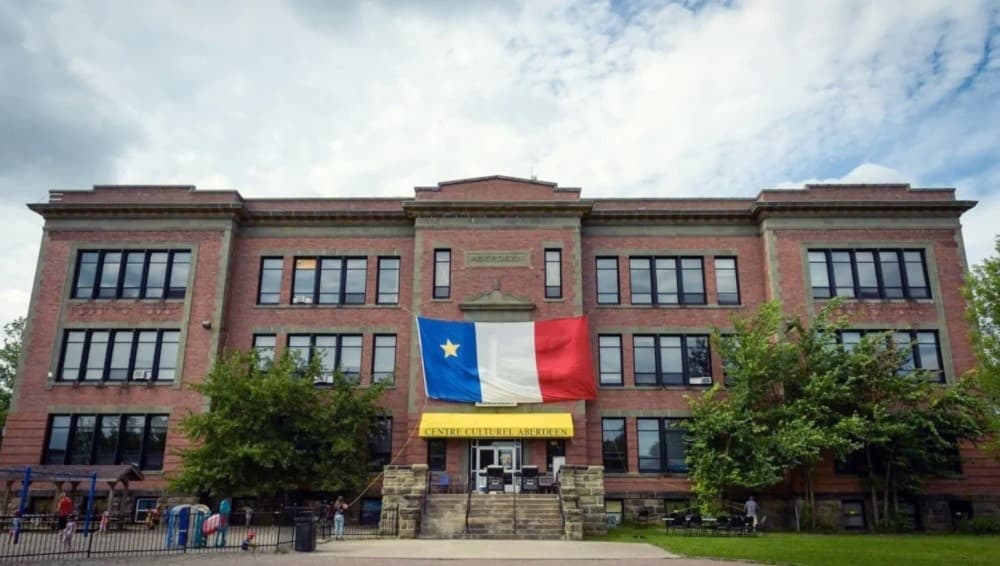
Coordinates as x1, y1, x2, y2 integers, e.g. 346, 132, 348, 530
34, 540, 746, 566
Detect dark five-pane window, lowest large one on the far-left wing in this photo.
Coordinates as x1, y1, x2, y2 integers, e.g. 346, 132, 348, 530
42, 415, 168, 470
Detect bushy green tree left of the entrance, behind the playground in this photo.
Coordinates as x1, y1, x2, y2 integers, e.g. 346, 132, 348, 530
171, 352, 382, 502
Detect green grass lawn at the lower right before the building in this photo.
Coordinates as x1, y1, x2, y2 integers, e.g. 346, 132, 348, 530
595, 527, 1000, 566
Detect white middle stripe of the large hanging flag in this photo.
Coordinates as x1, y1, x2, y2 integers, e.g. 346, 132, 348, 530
476, 322, 542, 403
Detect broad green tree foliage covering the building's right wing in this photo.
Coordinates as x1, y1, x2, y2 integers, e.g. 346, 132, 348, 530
688, 301, 988, 525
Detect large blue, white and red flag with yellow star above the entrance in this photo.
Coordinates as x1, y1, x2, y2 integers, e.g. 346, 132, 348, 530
417, 316, 597, 403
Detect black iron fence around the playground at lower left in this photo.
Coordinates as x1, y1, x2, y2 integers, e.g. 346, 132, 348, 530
0, 507, 399, 562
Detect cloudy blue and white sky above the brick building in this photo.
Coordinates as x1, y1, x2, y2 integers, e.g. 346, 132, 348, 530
0, 0, 1000, 321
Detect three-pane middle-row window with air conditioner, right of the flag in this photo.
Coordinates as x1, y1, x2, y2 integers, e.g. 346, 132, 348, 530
632, 335, 712, 385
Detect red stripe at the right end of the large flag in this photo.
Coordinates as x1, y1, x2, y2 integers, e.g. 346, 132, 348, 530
535, 316, 597, 403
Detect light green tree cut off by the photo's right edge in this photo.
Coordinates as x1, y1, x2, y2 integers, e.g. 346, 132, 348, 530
964, 239, 1000, 450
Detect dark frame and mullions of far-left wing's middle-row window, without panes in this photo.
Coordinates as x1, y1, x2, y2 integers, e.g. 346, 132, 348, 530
54, 328, 182, 383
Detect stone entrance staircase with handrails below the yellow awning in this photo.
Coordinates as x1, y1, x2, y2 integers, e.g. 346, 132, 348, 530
420, 493, 563, 540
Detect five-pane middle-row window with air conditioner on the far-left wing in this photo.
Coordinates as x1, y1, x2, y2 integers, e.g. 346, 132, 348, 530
58, 330, 180, 381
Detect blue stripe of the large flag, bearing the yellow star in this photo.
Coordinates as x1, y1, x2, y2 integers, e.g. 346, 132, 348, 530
417, 317, 483, 403
